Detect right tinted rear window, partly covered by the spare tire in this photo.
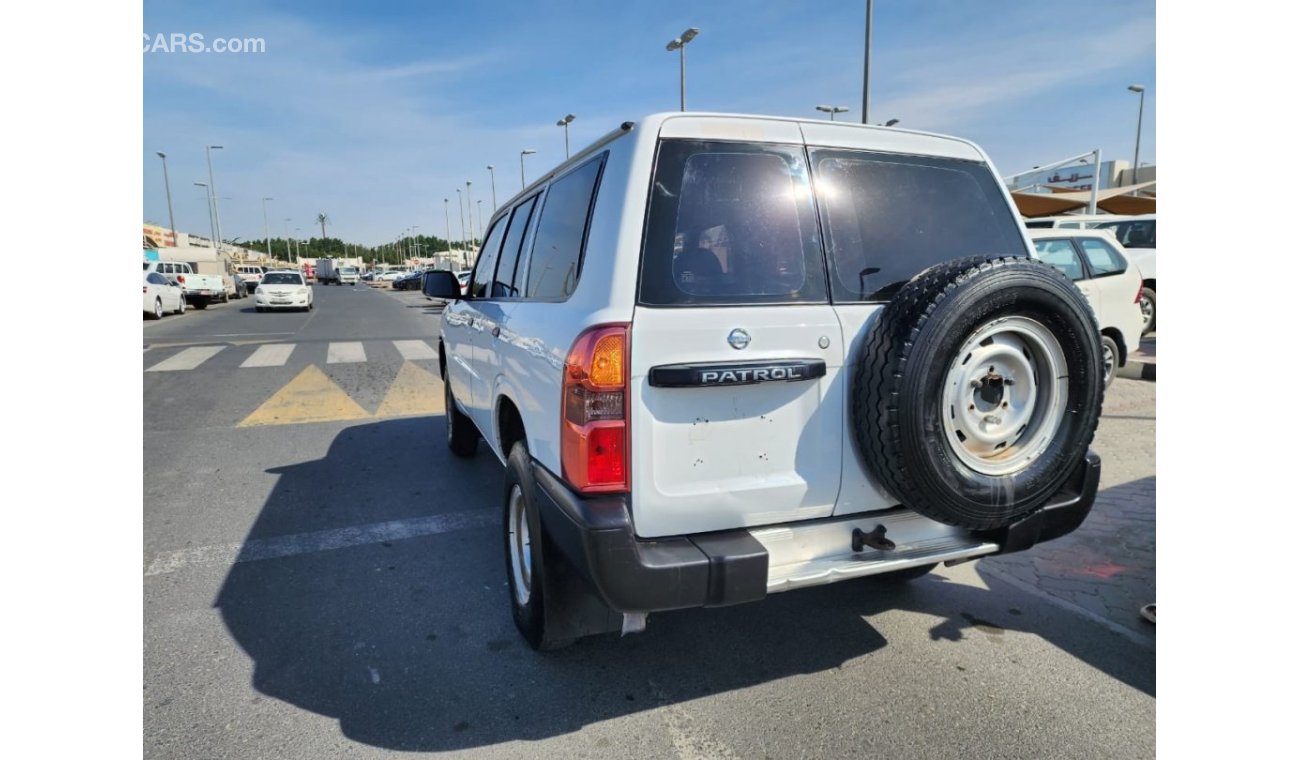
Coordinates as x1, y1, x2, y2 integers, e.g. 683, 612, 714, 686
813, 149, 1028, 301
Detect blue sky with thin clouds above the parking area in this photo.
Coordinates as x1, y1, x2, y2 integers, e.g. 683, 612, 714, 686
142, 0, 1157, 244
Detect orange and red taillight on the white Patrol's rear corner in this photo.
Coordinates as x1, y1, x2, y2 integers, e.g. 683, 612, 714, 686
560, 325, 631, 494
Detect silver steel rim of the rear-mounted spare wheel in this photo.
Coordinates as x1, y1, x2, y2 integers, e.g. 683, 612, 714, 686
943, 317, 1069, 475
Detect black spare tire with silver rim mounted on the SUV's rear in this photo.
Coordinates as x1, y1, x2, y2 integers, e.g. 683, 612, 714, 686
853, 257, 1104, 530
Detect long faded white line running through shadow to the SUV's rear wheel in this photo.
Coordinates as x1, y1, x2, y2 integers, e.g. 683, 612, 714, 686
144, 509, 499, 577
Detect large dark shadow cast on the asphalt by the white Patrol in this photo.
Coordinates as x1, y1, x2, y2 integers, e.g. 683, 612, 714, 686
215, 416, 1154, 751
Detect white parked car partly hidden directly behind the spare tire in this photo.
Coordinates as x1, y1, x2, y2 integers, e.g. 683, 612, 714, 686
1030, 229, 1144, 387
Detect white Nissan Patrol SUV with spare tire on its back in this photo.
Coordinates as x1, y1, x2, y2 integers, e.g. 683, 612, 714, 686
424, 113, 1102, 648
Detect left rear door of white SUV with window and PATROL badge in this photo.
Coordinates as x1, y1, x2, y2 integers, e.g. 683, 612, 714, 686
629, 137, 845, 537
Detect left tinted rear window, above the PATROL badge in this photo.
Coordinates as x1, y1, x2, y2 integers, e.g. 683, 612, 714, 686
641, 140, 827, 305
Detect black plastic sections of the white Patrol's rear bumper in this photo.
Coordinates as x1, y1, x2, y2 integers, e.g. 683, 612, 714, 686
533, 451, 1101, 612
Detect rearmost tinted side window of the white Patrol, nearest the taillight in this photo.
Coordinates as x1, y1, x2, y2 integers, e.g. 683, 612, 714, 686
527, 153, 606, 300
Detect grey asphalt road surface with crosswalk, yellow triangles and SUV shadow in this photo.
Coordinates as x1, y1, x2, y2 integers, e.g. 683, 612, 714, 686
142, 286, 1156, 760
